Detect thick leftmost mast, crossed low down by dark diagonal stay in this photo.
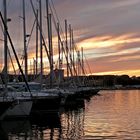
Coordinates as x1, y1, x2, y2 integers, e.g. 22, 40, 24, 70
3, 0, 8, 93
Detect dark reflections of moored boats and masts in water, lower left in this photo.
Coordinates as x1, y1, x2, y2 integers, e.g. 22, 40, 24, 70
0, 100, 84, 140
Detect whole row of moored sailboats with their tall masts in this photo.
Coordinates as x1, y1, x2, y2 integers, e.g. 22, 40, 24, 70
0, 0, 99, 119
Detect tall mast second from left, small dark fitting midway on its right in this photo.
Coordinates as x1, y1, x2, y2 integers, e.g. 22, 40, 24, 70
22, 0, 28, 81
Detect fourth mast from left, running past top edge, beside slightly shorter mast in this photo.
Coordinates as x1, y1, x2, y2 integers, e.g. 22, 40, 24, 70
39, 0, 43, 88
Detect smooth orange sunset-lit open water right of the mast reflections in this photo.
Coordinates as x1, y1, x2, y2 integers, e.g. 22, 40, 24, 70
84, 90, 140, 140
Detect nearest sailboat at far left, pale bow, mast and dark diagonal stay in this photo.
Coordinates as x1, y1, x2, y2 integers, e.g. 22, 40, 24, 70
0, 0, 32, 119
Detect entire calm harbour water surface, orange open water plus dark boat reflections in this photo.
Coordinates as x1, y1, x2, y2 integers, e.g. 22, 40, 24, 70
0, 90, 140, 140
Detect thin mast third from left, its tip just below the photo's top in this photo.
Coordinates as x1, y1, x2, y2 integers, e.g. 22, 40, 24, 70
35, 10, 38, 76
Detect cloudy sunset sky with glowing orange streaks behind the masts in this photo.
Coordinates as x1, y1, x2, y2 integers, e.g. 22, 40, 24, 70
0, 0, 140, 76
